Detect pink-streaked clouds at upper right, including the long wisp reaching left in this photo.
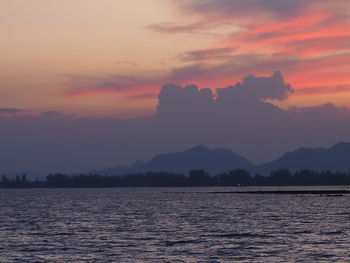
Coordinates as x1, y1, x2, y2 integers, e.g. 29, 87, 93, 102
65, 0, 350, 104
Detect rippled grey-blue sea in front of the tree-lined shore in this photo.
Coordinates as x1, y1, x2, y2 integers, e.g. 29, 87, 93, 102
0, 187, 350, 263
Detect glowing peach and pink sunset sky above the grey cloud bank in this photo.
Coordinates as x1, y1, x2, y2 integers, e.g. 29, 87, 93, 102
0, 0, 350, 117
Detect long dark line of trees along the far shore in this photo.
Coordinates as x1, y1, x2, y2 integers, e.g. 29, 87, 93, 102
0, 169, 350, 188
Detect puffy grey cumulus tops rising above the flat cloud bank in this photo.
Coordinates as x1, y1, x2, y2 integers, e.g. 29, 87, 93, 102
157, 71, 293, 117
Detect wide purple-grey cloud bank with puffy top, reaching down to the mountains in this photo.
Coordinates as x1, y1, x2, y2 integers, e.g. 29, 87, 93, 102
0, 71, 350, 175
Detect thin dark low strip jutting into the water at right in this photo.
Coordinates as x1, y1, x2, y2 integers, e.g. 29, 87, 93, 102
210, 190, 350, 195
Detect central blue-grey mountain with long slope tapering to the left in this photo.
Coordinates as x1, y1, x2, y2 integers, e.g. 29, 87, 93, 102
99, 145, 254, 175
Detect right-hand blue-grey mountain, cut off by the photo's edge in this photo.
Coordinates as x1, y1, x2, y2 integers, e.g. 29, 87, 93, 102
255, 142, 350, 174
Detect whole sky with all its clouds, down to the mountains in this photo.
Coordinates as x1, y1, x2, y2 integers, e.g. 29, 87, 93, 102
0, 0, 350, 175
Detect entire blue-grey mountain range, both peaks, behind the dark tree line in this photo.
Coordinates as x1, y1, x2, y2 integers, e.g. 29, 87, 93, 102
94, 142, 350, 175
